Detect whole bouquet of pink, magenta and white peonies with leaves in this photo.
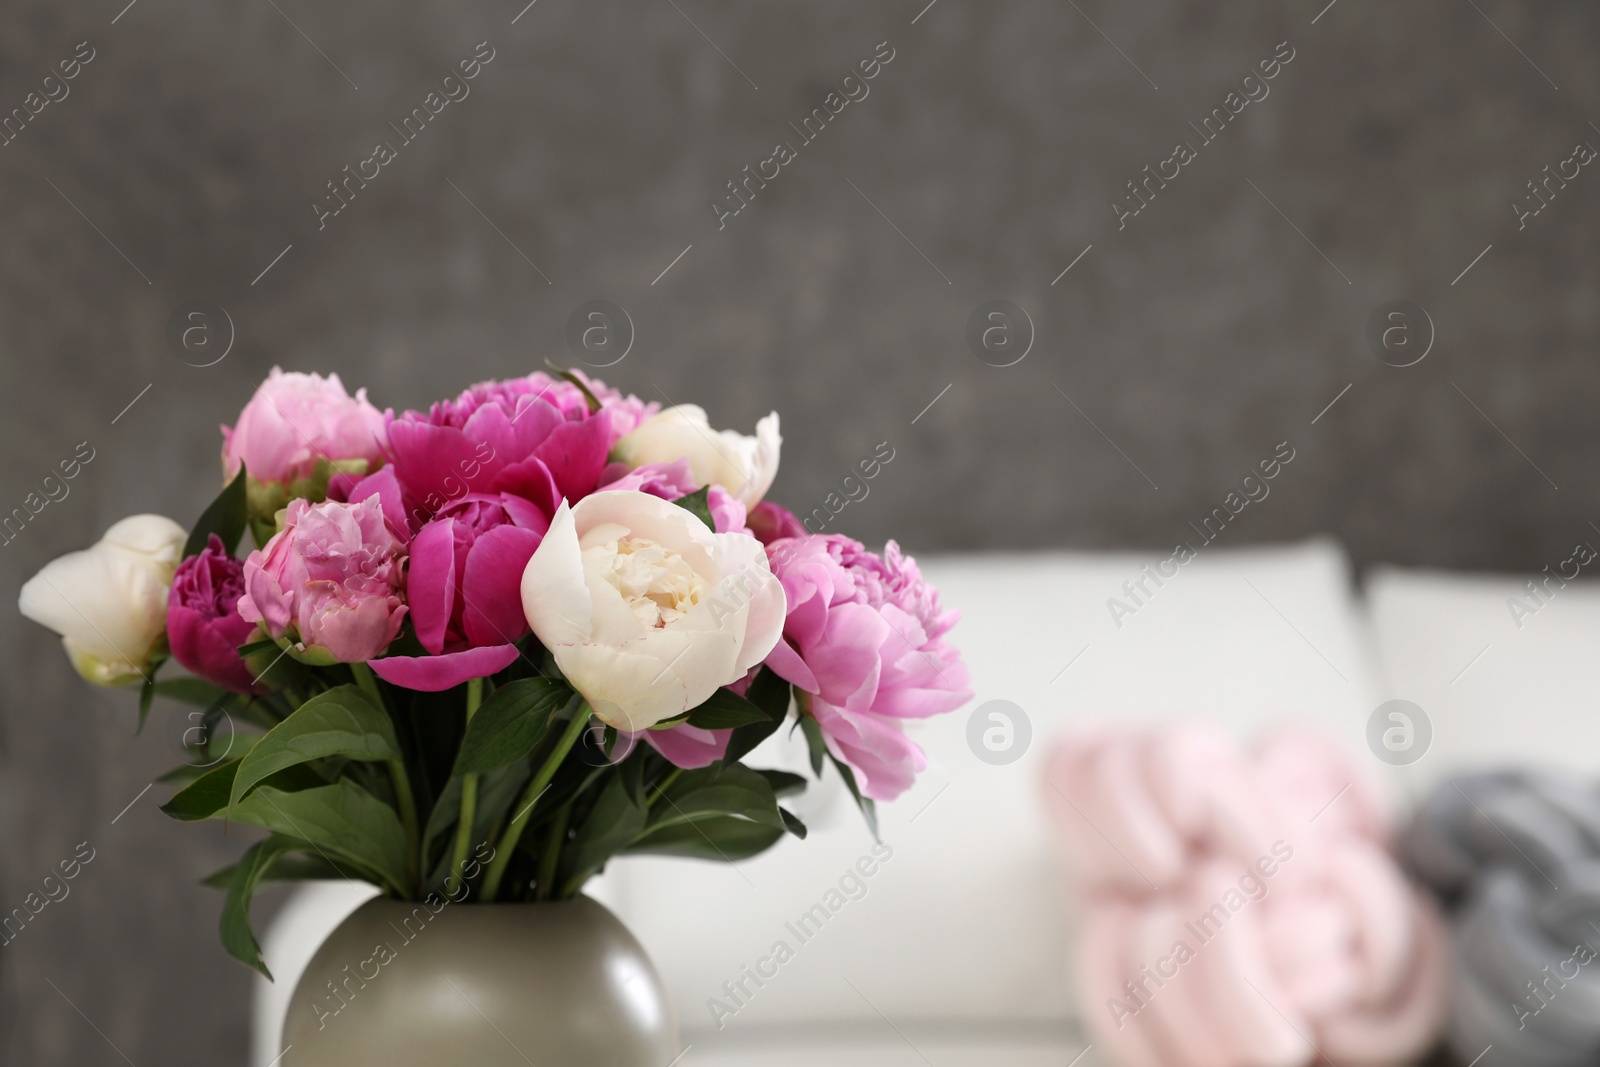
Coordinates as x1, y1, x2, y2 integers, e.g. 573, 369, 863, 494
21, 370, 970, 973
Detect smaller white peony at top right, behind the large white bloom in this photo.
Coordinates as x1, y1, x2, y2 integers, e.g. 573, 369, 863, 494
611, 403, 784, 509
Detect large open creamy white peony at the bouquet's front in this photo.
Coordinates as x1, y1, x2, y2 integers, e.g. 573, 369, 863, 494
522, 491, 784, 731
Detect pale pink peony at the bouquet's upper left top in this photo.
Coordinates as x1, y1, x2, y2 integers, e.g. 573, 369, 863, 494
222, 366, 384, 485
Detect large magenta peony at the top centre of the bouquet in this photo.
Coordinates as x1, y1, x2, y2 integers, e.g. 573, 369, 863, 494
389, 371, 654, 530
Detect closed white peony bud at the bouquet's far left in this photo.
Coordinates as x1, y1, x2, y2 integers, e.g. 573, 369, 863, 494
18, 515, 187, 685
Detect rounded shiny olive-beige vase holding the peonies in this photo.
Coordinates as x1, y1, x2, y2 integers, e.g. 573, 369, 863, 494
283, 897, 682, 1067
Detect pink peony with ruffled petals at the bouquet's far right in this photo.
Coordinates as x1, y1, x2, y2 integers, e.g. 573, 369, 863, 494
766, 534, 971, 800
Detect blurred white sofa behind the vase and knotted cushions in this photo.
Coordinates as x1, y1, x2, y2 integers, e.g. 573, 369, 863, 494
254, 541, 1600, 1067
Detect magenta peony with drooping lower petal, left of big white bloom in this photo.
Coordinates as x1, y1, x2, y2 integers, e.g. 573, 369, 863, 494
373, 490, 550, 693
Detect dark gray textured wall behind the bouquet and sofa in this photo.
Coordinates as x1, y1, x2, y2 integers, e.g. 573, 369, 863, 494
0, 0, 1600, 1065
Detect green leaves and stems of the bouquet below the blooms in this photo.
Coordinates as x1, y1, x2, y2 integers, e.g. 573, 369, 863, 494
150, 460, 877, 974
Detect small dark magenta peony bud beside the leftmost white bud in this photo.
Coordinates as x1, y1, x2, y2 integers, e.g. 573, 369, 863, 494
166, 534, 267, 693
